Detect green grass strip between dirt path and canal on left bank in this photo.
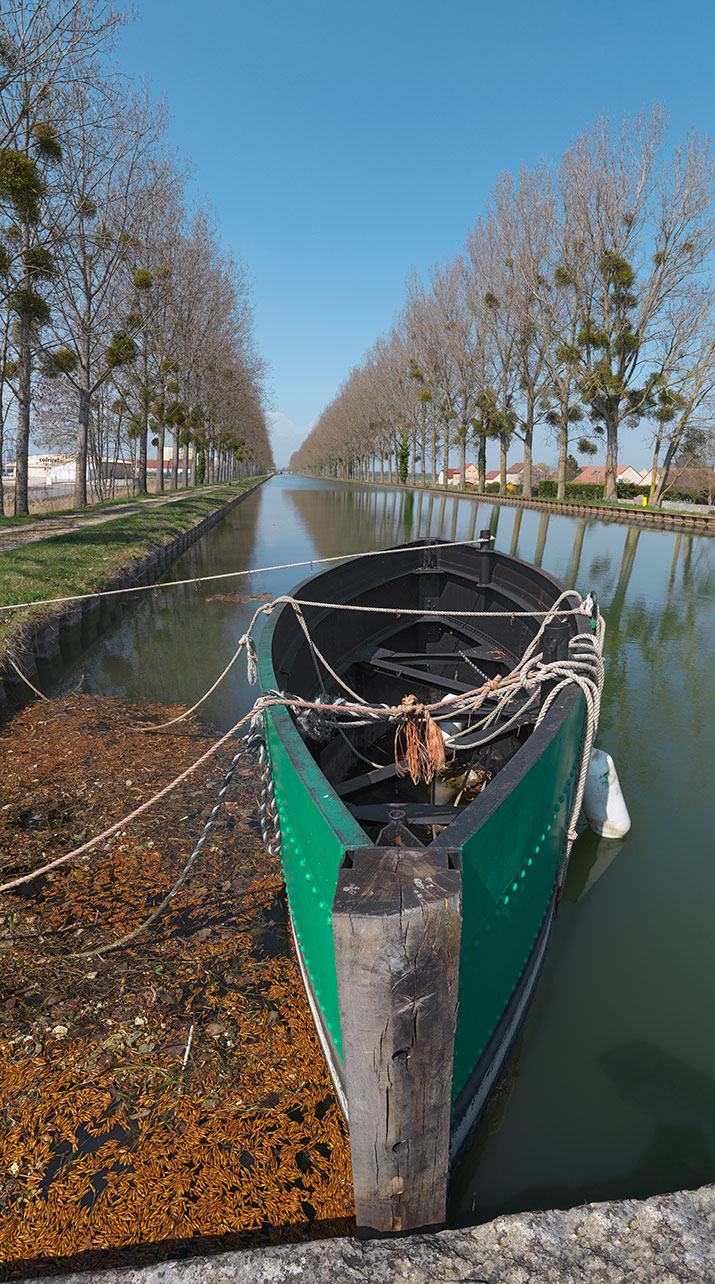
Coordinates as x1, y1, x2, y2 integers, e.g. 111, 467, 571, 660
0, 478, 265, 663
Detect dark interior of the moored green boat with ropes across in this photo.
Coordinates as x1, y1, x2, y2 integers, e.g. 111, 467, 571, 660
272, 533, 579, 847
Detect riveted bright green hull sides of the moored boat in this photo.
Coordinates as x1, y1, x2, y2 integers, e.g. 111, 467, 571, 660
259, 536, 585, 1227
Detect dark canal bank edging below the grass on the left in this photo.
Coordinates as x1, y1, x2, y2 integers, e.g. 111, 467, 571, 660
0, 478, 266, 725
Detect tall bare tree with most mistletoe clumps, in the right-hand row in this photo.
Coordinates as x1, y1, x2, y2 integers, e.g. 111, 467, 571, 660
560, 107, 715, 498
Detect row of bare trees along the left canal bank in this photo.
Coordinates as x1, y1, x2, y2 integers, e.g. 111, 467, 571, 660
0, 0, 272, 512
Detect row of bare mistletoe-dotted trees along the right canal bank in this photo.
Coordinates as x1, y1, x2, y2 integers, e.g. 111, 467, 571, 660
291, 105, 715, 502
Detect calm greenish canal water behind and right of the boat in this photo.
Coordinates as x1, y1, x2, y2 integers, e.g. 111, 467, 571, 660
55, 476, 715, 1224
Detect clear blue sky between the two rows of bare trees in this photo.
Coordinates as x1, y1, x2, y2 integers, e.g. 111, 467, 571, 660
117, 0, 715, 466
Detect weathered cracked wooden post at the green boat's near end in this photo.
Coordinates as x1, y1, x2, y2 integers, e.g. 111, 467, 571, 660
332, 847, 462, 1234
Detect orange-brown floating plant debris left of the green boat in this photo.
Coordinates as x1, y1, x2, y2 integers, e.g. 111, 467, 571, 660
0, 695, 353, 1278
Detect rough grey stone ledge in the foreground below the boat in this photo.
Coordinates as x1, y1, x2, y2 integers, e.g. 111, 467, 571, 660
15, 1186, 715, 1284
